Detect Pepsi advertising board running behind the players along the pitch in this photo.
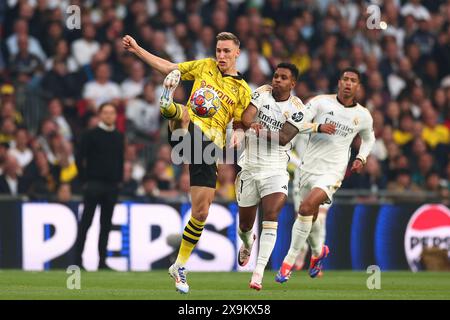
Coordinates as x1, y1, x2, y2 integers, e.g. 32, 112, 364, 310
0, 201, 450, 271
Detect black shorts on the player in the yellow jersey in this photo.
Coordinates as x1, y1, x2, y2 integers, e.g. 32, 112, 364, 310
168, 122, 222, 189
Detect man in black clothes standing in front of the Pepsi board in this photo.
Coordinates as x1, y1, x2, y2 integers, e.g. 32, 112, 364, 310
76, 103, 124, 269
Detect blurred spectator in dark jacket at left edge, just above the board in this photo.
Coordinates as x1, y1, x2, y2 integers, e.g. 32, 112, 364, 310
0, 154, 25, 196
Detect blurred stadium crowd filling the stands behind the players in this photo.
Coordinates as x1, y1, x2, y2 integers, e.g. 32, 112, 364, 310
0, 0, 450, 201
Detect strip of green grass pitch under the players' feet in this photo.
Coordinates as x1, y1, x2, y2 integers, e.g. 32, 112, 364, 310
0, 270, 450, 300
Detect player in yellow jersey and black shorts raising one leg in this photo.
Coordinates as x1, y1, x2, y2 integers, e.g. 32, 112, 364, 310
122, 32, 251, 293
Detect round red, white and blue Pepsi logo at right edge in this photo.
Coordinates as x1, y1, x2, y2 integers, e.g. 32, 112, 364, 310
405, 204, 450, 271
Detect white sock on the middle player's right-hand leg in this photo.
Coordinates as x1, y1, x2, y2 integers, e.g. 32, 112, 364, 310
255, 221, 278, 276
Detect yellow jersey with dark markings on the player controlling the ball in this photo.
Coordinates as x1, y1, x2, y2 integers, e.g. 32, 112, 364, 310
178, 58, 251, 147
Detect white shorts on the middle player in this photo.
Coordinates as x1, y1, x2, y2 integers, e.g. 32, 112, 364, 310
235, 169, 289, 207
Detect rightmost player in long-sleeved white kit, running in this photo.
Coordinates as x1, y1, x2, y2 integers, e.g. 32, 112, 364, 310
275, 68, 375, 283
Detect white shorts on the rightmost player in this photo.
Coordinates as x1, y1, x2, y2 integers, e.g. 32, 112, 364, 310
293, 168, 342, 210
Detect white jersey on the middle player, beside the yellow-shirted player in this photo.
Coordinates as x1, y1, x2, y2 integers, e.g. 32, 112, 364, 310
238, 85, 305, 172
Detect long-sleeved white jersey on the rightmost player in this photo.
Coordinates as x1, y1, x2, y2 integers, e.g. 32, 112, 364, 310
288, 94, 375, 178
